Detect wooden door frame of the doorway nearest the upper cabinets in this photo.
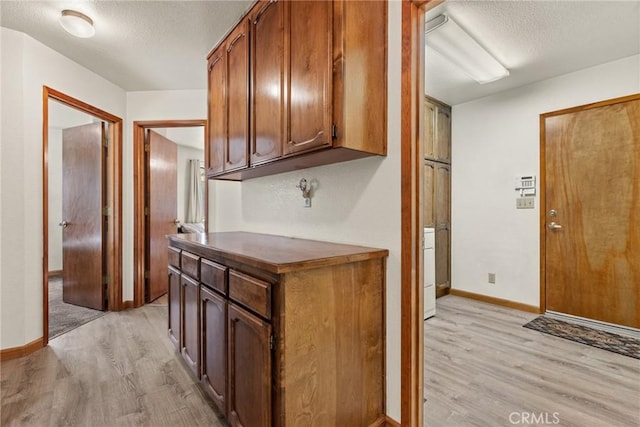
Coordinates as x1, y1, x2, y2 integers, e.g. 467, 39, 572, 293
133, 119, 209, 307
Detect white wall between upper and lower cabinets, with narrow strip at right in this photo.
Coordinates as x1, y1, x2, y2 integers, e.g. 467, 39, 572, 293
210, 1, 401, 420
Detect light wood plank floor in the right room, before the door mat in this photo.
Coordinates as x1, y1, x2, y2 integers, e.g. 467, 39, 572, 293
424, 296, 640, 427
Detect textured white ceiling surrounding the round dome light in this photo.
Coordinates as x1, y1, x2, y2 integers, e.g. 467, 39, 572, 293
0, 0, 252, 91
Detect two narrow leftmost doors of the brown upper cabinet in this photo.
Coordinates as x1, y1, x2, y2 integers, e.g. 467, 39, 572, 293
207, 20, 249, 175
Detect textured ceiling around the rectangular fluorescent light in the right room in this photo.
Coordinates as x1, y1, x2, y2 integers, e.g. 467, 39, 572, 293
425, 0, 640, 105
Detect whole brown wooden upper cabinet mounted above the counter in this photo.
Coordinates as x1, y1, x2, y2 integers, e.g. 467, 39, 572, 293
207, 0, 387, 180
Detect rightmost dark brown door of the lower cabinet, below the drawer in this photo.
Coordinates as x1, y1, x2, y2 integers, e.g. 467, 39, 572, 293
227, 304, 271, 427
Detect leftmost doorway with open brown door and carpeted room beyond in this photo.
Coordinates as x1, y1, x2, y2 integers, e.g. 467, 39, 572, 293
42, 86, 122, 345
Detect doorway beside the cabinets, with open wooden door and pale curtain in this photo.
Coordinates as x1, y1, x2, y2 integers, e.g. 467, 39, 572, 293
133, 120, 207, 307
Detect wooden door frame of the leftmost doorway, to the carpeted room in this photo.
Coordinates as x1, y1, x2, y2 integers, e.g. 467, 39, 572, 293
42, 86, 122, 346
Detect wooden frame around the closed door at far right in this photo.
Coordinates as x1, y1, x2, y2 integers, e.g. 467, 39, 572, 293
539, 94, 640, 313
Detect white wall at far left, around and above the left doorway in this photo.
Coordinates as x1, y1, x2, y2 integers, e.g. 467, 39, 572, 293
0, 28, 126, 349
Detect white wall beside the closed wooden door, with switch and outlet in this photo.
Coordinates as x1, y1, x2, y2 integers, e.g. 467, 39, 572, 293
451, 56, 640, 306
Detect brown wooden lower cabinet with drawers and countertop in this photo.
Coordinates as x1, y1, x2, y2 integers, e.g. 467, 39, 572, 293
168, 233, 388, 427
